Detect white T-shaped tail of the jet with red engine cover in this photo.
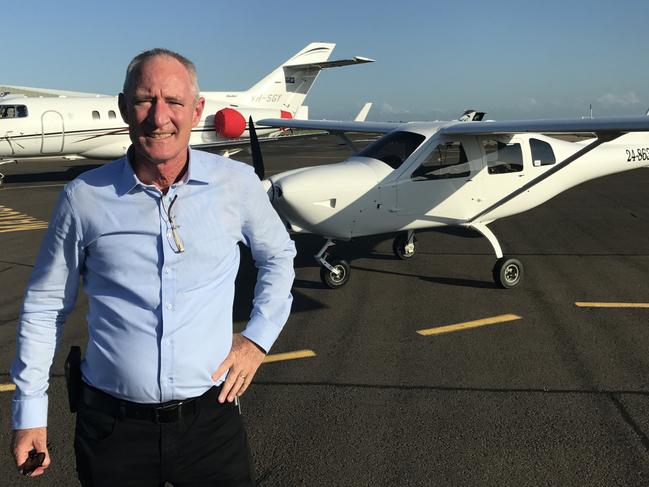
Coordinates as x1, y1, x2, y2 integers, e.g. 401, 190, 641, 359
245, 42, 373, 117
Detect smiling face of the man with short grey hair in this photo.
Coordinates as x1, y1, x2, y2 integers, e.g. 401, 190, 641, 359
119, 56, 205, 164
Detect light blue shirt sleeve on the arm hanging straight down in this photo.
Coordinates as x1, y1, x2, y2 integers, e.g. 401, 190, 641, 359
11, 190, 83, 429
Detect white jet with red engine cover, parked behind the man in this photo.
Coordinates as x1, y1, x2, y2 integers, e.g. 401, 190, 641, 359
0, 43, 372, 175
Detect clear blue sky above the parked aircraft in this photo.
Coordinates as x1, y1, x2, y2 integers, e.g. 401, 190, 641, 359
5, 0, 649, 121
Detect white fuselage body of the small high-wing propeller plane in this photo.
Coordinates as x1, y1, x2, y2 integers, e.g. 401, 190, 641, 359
269, 127, 649, 240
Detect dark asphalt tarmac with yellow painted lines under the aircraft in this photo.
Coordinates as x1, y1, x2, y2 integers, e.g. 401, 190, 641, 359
0, 137, 649, 487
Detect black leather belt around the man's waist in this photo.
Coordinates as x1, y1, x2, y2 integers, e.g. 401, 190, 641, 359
81, 383, 219, 423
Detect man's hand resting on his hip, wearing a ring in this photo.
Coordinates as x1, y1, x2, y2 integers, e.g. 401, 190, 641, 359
212, 333, 266, 403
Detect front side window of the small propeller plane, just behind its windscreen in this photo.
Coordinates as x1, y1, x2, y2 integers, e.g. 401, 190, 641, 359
410, 140, 471, 181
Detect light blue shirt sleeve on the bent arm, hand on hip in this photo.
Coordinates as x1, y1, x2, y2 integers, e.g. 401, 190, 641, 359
242, 175, 295, 353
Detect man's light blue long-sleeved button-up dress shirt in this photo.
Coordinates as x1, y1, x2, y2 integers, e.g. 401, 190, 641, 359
11, 149, 295, 429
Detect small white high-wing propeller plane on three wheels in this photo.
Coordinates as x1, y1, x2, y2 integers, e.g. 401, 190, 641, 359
251, 111, 649, 288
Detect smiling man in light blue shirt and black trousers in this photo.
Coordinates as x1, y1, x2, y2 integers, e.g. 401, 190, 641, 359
12, 49, 295, 487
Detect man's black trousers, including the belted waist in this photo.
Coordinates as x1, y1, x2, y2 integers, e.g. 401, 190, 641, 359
74, 388, 255, 487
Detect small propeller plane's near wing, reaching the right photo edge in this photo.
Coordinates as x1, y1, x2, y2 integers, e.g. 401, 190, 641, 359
439, 116, 649, 139
